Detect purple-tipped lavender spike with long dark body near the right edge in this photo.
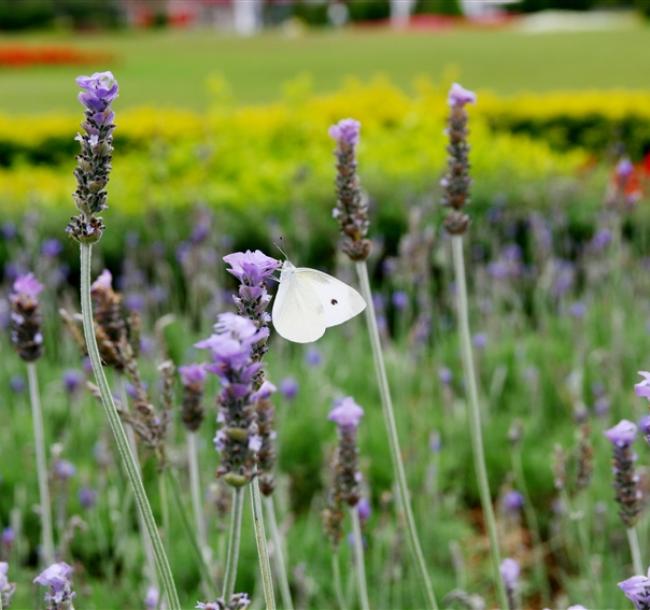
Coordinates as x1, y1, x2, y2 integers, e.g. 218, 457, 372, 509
605, 419, 642, 528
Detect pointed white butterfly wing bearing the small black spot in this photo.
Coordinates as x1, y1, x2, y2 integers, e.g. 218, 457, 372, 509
294, 267, 366, 327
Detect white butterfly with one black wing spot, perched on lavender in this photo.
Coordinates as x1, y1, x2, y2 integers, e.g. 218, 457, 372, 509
272, 261, 366, 343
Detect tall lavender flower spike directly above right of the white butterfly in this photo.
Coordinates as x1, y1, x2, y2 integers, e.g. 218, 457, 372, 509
328, 119, 371, 261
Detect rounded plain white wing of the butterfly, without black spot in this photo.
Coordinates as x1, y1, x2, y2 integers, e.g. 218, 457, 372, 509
271, 263, 327, 343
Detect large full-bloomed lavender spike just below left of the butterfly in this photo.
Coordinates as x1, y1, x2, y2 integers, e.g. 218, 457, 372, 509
196, 313, 265, 487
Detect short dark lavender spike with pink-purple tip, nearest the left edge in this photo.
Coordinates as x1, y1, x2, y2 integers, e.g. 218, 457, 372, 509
9, 273, 43, 362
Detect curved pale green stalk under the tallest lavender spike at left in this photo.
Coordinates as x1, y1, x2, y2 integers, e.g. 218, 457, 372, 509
80, 244, 181, 610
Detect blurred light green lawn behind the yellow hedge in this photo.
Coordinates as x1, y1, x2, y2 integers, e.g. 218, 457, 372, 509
0, 26, 650, 112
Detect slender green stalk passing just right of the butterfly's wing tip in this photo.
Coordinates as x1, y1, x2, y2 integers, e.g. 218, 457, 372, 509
356, 261, 438, 610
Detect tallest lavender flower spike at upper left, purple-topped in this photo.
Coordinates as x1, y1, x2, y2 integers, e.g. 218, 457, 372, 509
66, 72, 118, 244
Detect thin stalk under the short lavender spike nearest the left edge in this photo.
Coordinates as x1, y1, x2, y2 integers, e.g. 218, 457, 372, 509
27, 362, 54, 565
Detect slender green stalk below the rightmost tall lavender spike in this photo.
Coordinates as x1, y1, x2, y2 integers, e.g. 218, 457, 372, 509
451, 235, 508, 608
